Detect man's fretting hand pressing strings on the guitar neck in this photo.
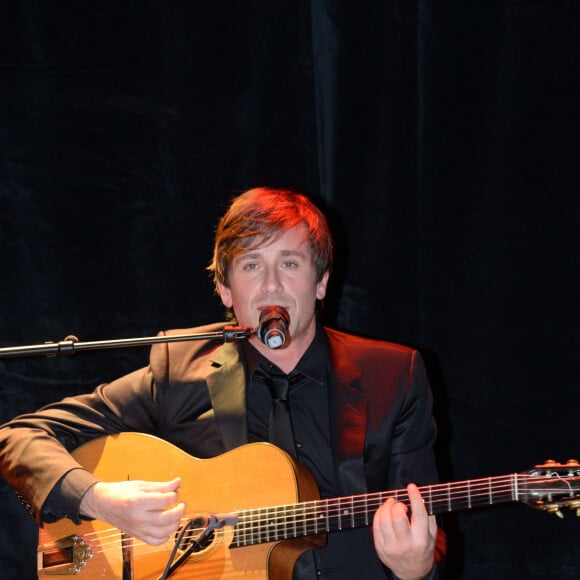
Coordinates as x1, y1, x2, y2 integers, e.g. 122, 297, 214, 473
373, 484, 437, 580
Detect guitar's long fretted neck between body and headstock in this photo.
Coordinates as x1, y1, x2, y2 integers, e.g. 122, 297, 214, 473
232, 474, 529, 547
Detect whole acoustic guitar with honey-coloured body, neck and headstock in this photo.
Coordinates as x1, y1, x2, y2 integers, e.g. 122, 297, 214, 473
37, 433, 580, 580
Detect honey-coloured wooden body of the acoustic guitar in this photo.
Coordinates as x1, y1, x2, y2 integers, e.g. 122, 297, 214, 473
38, 433, 323, 580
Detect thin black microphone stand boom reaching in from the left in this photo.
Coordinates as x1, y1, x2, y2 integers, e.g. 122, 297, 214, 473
0, 326, 257, 358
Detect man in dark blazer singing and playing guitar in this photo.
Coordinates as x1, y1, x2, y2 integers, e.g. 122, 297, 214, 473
0, 188, 439, 580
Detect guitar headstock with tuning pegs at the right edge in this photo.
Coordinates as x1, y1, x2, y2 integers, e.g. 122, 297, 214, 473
520, 459, 580, 518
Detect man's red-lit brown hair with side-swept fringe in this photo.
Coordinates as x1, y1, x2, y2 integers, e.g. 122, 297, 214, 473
208, 187, 333, 290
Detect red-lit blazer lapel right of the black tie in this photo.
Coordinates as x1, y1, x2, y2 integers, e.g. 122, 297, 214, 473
327, 332, 368, 493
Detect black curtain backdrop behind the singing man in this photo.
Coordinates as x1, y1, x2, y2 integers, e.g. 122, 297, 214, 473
0, 0, 580, 579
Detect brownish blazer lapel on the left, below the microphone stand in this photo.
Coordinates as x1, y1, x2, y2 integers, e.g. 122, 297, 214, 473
207, 343, 248, 450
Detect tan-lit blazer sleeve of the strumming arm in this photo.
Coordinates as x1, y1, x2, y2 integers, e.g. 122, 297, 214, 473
0, 368, 156, 524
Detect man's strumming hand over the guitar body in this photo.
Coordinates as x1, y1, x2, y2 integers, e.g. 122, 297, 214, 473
80, 478, 185, 546
